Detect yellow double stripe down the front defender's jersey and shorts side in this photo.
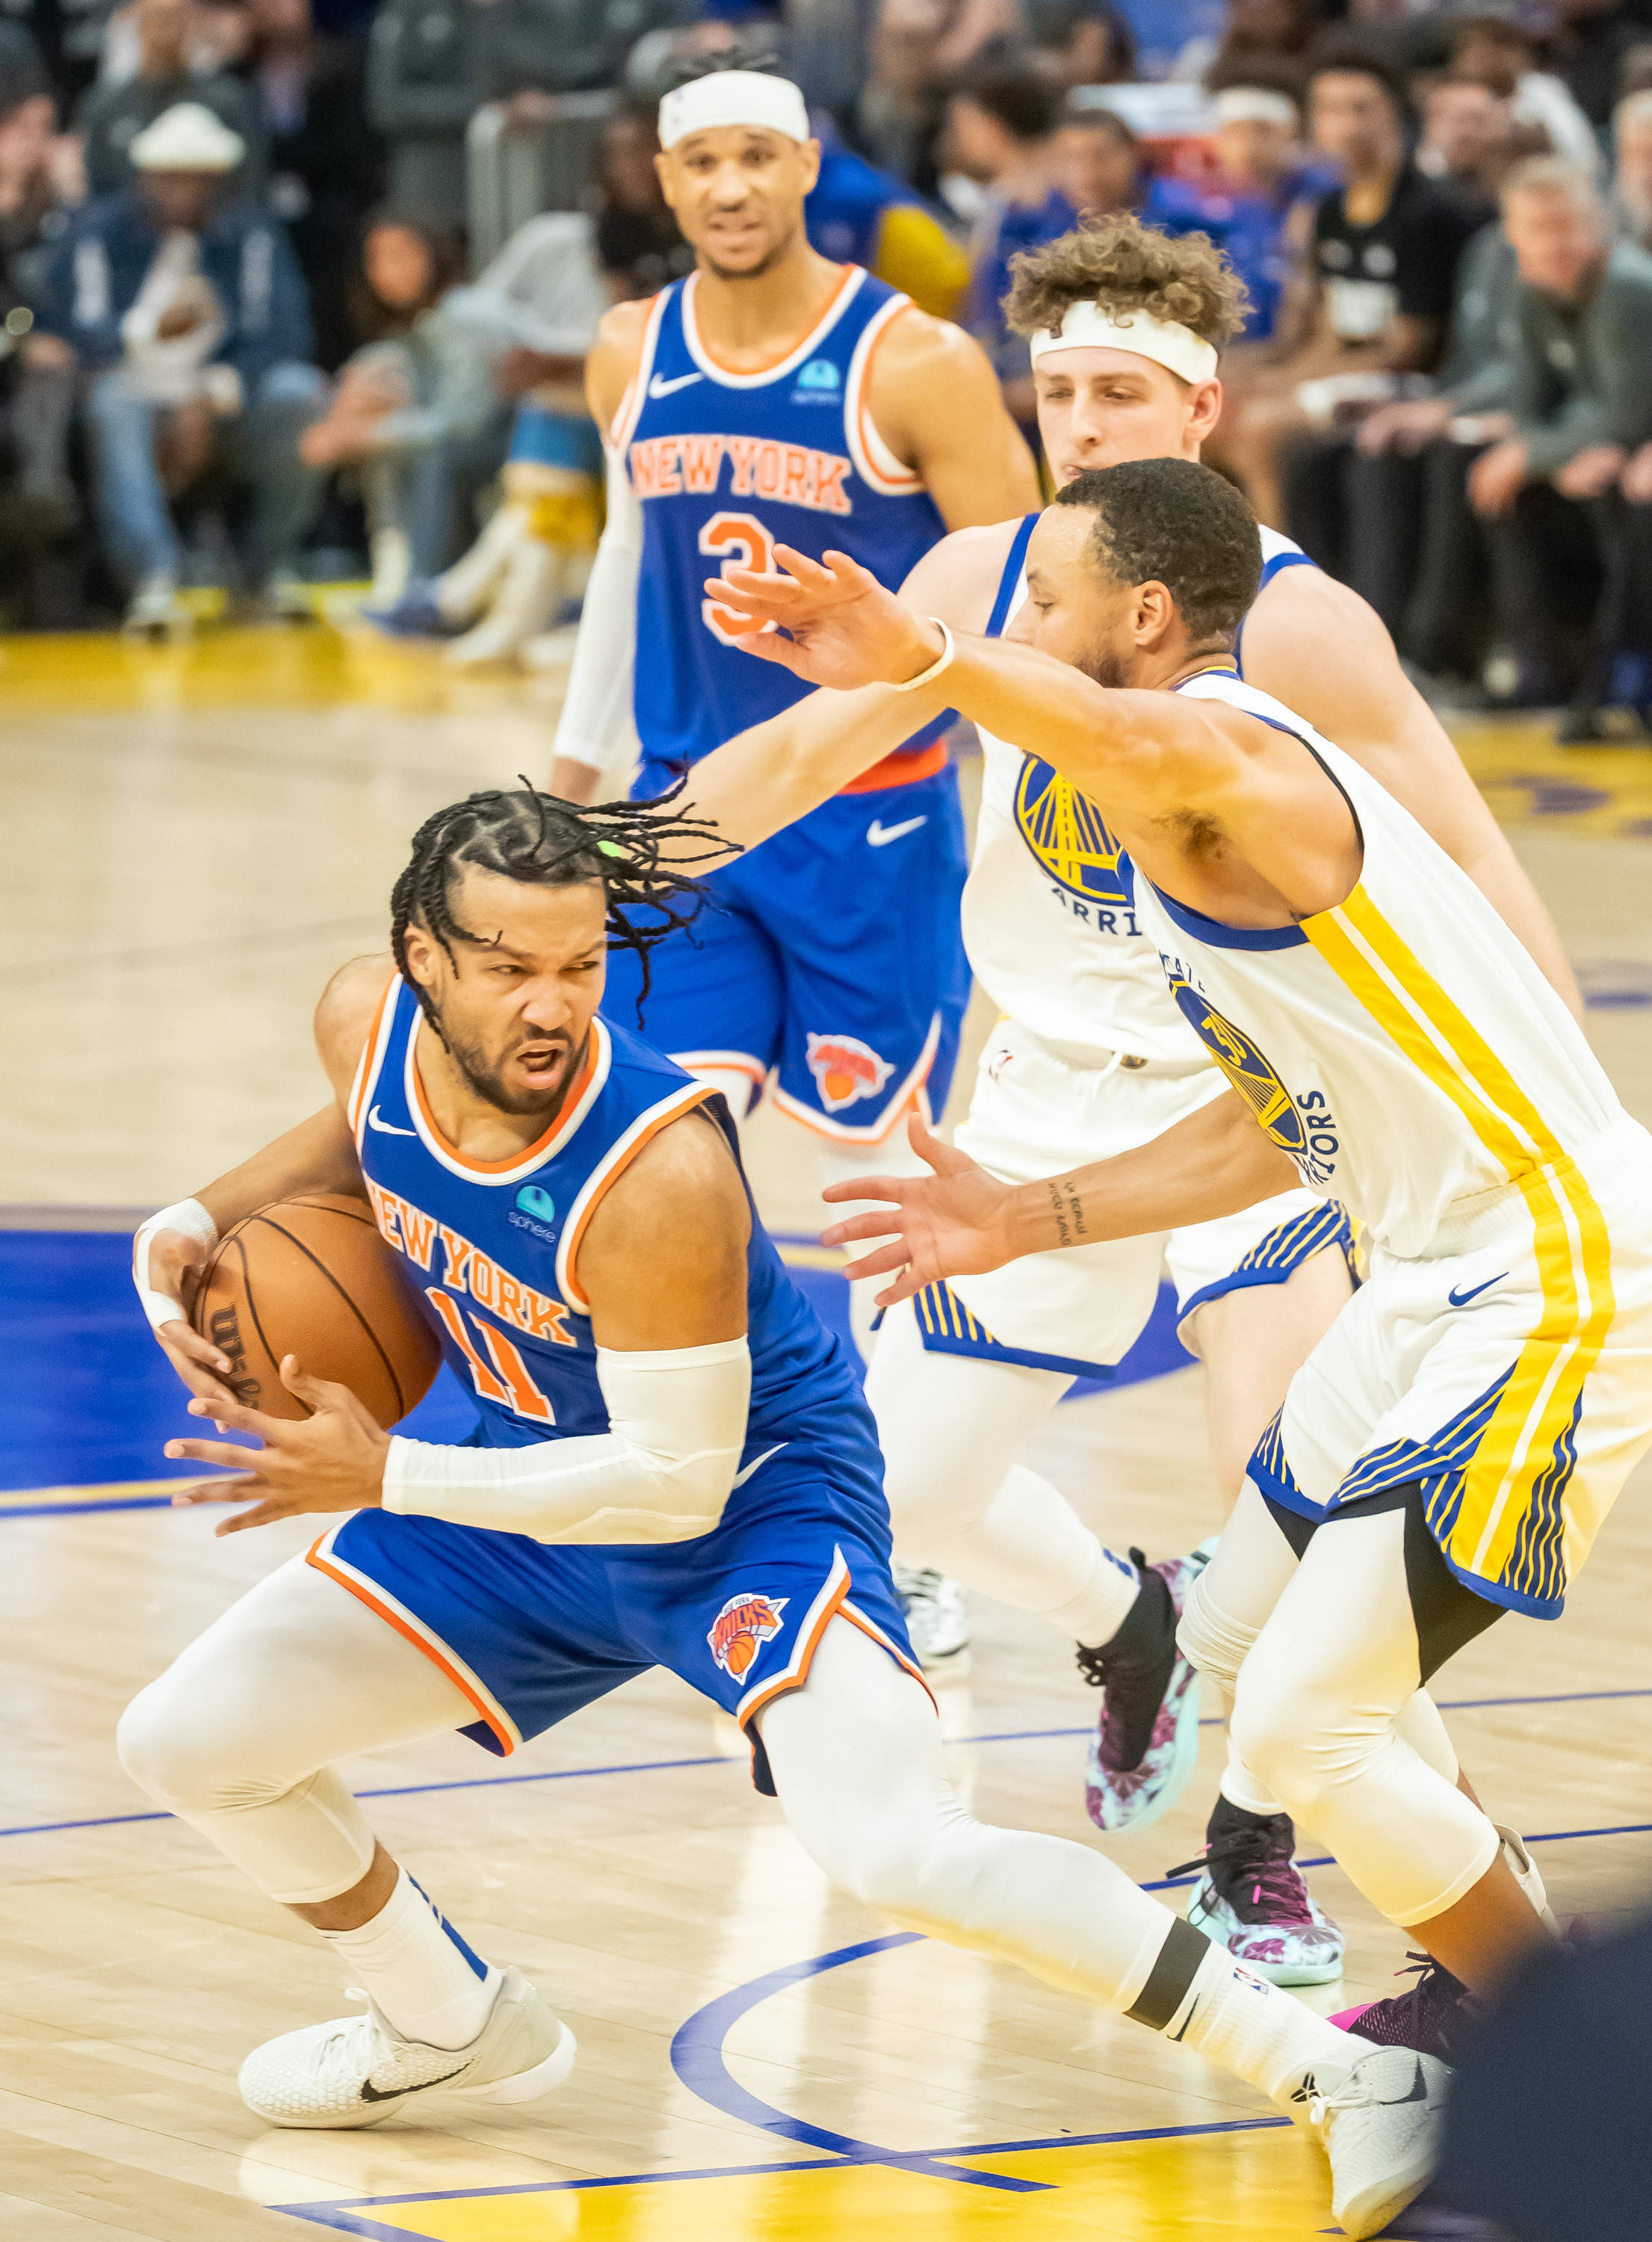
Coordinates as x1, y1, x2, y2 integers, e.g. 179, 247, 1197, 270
1302, 888, 1614, 1594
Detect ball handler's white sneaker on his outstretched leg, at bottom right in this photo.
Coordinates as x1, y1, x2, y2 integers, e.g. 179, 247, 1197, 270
1298, 2047, 1450, 2242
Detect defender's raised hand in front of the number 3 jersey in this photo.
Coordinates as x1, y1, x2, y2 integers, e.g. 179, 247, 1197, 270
706, 545, 944, 691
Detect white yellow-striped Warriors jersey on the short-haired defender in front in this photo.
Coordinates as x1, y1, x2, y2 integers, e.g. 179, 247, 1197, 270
1134, 670, 1625, 1258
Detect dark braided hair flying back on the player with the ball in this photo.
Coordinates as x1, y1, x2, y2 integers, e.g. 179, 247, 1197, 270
390, 778, 737, 1034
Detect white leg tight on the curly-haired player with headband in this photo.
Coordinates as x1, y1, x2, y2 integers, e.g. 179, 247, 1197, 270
865, 1300, 1134, 1643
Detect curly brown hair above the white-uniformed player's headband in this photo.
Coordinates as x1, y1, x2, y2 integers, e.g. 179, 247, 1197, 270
1004, 211, 1251, 348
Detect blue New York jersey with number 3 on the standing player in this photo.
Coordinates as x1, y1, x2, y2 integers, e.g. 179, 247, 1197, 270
614, 265, 946, 762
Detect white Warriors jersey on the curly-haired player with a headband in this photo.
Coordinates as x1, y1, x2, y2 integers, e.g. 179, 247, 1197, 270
962, 513, 1307, 1065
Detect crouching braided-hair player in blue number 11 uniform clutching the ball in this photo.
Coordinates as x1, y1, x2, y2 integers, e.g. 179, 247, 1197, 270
121, 791, 1446, 2235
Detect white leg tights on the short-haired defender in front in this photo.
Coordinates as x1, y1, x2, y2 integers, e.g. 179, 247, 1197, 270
1181, 1482, 1500, 1926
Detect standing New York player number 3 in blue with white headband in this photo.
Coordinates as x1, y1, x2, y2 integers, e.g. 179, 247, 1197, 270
551, 56, 1038, 1175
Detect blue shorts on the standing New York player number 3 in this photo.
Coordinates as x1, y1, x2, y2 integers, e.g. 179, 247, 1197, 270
603, 765, 968, 1143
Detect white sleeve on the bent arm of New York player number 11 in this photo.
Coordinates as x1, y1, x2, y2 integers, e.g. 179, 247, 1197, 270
383, 1338, 751, 1542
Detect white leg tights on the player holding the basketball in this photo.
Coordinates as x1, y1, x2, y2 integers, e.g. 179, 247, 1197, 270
121, 1560, 1345, 2105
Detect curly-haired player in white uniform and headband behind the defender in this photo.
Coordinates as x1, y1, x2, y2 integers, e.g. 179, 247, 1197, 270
672, 217, 1576, 1984
